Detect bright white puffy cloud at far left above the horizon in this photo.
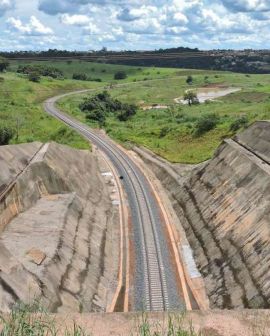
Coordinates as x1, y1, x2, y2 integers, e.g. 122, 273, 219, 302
7, 15, 53, 36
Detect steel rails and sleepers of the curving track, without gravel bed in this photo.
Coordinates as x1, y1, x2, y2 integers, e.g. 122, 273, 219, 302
44, 90, 170, 311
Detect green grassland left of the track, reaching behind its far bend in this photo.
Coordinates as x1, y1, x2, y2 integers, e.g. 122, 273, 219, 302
0, 60, 184, 149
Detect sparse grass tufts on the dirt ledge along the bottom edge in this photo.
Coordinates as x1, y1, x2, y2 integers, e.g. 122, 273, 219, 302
0, 300, 269, 336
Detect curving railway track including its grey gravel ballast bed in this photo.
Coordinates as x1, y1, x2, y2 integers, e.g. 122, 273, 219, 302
44, 90, 184, 311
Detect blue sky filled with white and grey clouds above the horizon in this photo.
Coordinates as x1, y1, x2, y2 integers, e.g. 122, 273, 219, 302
0, 0, 270, 51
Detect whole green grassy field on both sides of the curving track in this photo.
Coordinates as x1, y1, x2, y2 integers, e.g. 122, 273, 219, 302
0, 60, 270, 163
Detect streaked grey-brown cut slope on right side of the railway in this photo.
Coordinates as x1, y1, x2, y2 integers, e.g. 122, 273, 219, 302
137, 121, 270, 308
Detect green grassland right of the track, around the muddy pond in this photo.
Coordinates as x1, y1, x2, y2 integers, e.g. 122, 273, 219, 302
59, 70, 270, 163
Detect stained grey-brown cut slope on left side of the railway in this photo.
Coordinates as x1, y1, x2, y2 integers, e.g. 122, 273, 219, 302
0, 143, 119, 312
